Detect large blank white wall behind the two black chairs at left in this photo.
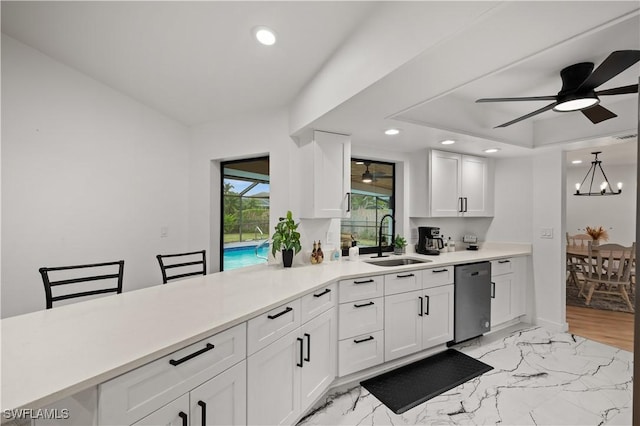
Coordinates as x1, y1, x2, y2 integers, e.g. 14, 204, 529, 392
2, 35, 189, 317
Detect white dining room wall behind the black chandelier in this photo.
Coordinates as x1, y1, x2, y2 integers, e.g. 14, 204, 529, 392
566, 163, 637, 245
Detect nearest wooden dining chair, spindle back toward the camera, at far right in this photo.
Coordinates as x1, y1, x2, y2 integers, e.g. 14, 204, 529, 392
580, 243, 636, 312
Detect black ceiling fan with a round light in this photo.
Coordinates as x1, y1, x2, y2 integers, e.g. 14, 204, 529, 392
476, 50, 640, 129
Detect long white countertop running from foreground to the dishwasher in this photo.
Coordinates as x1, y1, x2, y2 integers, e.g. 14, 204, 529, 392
0, 243, 531, 410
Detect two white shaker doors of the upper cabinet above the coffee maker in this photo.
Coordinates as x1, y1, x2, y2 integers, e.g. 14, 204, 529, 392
428, 150, 493, 217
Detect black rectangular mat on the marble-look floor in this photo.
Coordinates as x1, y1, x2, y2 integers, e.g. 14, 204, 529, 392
360, 349, 493, 414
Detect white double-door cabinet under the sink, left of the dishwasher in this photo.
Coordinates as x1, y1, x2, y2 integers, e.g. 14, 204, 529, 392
384, 284, 454, 361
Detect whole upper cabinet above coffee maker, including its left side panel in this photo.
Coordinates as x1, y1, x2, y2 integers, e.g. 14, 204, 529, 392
410, 150, 494, 217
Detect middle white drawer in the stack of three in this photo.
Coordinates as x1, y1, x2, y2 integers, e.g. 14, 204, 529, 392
338, 297, 384, 339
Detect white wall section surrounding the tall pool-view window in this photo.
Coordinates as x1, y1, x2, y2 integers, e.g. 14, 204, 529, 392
188, 109, 298, 271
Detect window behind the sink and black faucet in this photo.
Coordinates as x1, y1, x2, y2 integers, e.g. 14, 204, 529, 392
340, 158, 395, 255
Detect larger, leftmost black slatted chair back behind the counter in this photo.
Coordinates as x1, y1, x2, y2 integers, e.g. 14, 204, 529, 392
39, 260, 124, 309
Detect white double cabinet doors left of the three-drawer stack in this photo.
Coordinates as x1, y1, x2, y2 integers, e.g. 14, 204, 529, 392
247, 308, 337, 425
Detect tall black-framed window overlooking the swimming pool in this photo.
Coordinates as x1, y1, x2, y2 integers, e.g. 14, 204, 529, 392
220, 157, 269, 271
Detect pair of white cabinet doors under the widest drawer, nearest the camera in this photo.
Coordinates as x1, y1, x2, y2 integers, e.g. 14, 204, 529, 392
135, 361, 247, 426
